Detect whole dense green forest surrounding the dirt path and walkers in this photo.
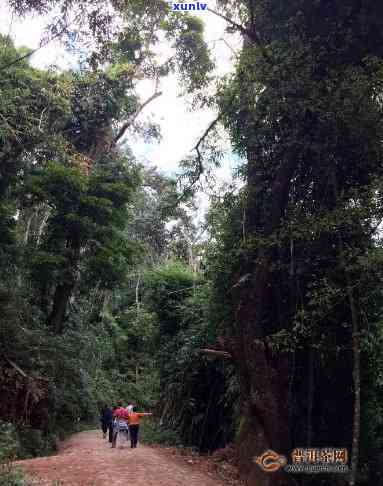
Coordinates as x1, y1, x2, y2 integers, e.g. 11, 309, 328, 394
0, 0, 383, 486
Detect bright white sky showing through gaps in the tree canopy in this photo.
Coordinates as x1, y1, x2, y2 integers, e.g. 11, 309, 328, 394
0, 0, 240, 220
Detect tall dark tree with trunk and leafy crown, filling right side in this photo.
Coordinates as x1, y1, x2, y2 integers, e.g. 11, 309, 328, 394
212, 1, 382, 485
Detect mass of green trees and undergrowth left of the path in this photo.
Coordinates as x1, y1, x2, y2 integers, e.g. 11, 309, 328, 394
0, 36, 146, 456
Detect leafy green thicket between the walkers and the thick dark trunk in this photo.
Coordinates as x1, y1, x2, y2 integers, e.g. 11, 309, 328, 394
139, 262, 238, 451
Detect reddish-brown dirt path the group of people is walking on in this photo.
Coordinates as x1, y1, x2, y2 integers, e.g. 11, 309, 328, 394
18, 431, 224, 486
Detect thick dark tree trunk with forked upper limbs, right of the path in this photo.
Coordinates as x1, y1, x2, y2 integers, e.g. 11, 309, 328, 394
235, 152, 296, 486
